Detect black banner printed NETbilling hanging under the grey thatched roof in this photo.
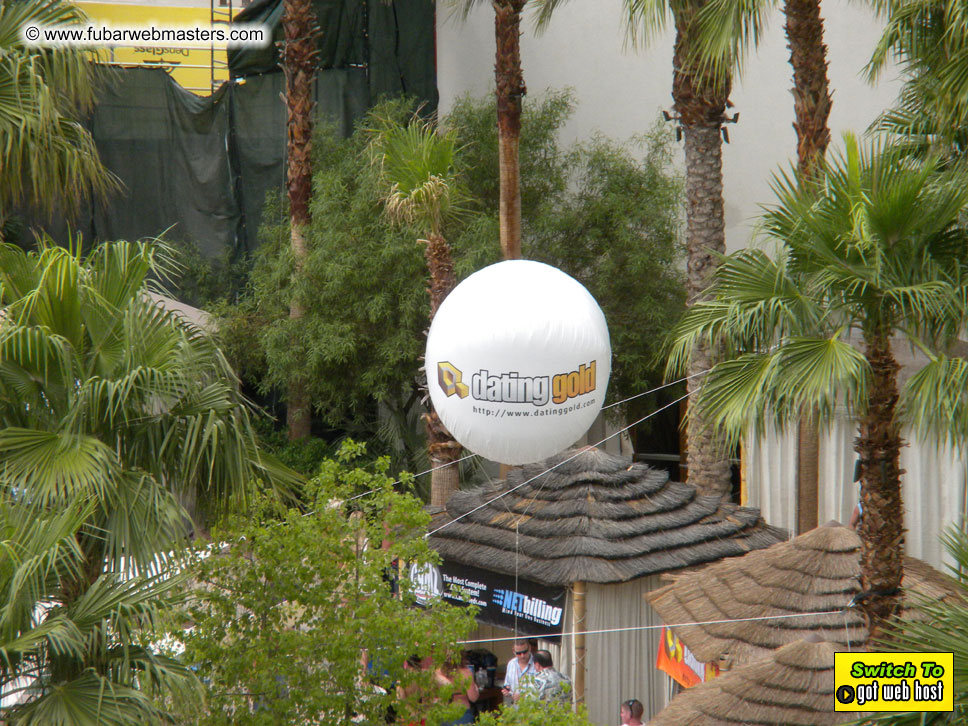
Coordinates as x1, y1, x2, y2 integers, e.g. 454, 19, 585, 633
410, 560, 567, 638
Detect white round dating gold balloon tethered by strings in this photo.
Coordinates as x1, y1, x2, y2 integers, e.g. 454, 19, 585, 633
426, 260, 611, 464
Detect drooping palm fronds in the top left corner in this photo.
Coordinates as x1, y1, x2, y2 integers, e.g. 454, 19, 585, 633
0, 0, 118, 226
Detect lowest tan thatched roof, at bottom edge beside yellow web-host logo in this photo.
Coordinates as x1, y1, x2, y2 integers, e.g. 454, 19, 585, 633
649, 640, 864, 726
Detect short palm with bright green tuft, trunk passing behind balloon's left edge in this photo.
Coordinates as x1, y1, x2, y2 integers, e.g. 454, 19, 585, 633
370, 116, 464, 506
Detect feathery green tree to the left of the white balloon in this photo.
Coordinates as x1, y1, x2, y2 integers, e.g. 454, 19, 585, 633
219, 102, 442, 480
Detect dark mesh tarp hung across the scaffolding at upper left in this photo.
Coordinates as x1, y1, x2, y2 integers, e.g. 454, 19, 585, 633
37, 0, 437, 256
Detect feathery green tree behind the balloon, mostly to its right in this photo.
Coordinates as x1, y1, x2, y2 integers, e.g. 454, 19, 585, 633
447, 92, 685, 430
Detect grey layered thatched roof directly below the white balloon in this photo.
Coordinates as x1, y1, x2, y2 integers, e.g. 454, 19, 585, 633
430, 449, 785, 585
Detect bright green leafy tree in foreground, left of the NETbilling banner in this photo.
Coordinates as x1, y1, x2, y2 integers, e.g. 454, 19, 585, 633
176, 444, 474, 726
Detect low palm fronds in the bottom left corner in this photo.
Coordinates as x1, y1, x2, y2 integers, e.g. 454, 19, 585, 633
0, 495, 199, 726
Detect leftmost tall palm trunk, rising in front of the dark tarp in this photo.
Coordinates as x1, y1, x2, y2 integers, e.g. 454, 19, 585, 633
282, 0, 316, 440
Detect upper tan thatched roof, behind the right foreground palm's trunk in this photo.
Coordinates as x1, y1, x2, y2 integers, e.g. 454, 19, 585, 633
648, 522, 958, 665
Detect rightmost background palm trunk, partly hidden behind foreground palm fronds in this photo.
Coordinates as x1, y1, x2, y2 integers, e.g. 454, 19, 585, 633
784, 0, 830, 533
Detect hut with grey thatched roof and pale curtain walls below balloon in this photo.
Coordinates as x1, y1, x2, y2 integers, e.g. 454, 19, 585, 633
430, 449, 786, 723
